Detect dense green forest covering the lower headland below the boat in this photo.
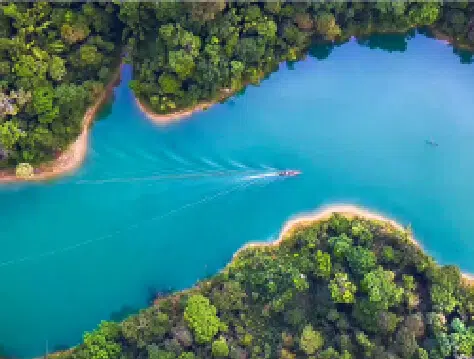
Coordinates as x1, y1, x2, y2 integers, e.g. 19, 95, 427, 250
53, 215, 474, 359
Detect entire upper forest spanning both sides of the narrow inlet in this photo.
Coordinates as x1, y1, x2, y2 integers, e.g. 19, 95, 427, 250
0, 0, 474, 178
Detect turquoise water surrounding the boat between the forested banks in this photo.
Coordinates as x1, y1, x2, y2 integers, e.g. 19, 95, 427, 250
0, 36, 474, 357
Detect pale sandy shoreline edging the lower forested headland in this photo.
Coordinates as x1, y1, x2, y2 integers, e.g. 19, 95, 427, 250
229, 204, 474, 285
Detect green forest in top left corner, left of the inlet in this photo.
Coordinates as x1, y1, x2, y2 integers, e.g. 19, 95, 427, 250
0, 2, 122, 165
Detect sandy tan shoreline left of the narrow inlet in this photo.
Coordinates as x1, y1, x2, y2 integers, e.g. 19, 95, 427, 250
0, 65, 122, 183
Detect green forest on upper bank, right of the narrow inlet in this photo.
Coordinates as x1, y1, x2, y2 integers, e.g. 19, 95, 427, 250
124, 0, 474, 113
